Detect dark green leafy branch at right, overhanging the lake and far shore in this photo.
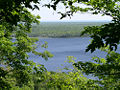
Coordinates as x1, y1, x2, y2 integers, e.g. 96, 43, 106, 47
81, 22, 120, 52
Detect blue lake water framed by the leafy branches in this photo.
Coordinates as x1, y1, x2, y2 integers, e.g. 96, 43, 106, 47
29, 37, 106, 71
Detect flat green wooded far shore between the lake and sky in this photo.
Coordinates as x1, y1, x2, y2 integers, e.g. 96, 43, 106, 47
29, 22, 106, 38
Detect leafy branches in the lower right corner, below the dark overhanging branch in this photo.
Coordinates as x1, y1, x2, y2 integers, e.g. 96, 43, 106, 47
74, 52, 120, 88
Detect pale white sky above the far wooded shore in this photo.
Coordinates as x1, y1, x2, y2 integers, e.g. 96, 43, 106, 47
31, 2, 112, 22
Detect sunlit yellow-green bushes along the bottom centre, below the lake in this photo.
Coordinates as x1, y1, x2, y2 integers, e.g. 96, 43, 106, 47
12, 56, 102, 90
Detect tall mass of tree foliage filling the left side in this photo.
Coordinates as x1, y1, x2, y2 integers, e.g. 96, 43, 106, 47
0, 0, 52, 90
